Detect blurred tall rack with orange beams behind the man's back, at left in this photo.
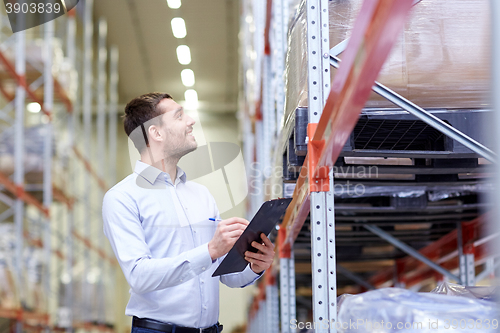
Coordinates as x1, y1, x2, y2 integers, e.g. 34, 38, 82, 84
0, 0, 118, 332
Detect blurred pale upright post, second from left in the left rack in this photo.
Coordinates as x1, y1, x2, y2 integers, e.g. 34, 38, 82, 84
43, 17, 57, 326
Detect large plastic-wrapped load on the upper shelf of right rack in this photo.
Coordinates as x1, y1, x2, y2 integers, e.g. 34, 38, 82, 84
285, 0, 490, 131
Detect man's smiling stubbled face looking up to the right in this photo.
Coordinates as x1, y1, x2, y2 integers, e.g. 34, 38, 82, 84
158, 98, 198, 158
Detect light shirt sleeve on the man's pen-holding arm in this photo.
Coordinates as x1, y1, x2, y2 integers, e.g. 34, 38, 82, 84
102, 190, 212, 294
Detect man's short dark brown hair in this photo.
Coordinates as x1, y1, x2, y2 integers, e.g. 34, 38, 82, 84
123, 92, 172, 153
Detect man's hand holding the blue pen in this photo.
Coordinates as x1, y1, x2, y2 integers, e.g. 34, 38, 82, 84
208, 217, 249, 260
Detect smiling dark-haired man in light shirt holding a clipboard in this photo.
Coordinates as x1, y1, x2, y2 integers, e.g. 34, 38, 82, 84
102, 93, 274, 333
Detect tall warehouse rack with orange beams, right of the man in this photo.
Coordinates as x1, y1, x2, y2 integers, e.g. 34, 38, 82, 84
241, 0, 498, 332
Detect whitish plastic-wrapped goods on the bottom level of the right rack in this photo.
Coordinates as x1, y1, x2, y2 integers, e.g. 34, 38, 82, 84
336, 288, 499, 333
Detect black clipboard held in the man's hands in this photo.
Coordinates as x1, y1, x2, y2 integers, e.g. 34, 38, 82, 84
212, 198, 292, 276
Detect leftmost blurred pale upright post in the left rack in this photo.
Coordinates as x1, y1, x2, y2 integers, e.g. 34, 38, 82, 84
14, 24, 26, 333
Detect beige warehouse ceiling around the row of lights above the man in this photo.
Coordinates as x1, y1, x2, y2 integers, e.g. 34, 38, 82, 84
94, 0, 239, 112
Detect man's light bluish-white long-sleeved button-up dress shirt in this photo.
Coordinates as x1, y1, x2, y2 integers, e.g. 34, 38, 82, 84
102, 161, 262, 328
